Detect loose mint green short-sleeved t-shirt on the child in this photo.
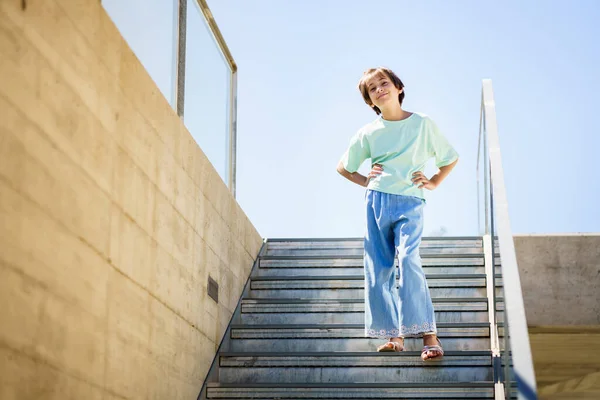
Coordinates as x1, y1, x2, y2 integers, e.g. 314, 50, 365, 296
341, 113, 458, 199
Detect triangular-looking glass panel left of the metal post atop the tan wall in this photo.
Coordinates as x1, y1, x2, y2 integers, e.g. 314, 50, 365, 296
102, 0, 178, 107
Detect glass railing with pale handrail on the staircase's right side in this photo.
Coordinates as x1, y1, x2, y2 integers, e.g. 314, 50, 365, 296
477, 79, 537, 400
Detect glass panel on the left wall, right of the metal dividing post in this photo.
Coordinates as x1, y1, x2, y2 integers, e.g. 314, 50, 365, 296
183, 0, 231, 185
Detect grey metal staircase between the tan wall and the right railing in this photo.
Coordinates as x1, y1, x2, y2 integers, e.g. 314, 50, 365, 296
199, 237, 516, 399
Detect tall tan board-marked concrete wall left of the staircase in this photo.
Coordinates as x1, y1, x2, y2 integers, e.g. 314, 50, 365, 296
0, 0, 262, 400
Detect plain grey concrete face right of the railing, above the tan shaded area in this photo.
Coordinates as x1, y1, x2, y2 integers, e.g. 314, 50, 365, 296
514, 234, 600, 326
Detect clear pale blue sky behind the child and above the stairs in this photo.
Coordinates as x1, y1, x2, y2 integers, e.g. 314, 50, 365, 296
104, 0, 600, 237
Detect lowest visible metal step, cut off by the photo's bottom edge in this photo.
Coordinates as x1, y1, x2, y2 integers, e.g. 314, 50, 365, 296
207, 381, 494, 400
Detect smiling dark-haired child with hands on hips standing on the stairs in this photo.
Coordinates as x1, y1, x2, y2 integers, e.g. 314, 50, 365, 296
337, 68, 458, 360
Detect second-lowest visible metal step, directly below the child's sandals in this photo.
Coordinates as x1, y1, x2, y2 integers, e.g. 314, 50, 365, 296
219, 351, 493, 383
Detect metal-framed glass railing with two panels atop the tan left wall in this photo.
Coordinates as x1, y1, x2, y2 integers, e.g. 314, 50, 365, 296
102, 0, 237, 196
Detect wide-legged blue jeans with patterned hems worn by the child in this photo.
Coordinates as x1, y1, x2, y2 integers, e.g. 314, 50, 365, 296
364, 190, 437, 338
